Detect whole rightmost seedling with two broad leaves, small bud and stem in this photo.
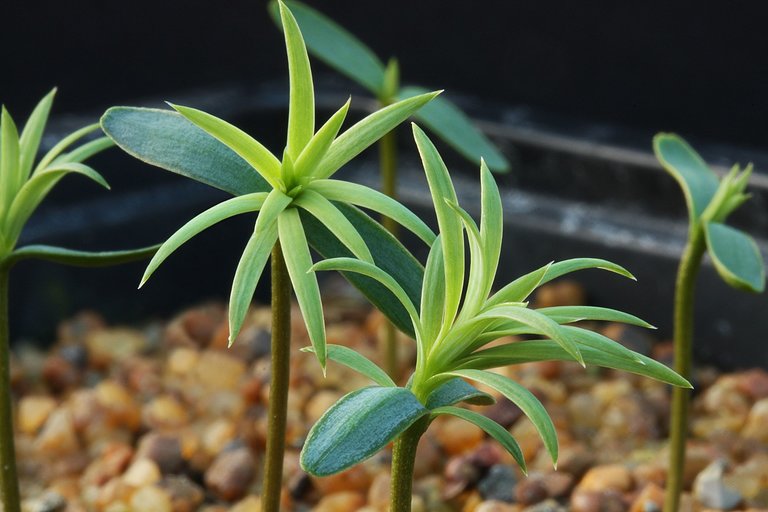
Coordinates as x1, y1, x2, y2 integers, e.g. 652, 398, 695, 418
653, 133, 765, 512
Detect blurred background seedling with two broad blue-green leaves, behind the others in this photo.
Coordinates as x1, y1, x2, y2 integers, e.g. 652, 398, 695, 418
270, 0, 509, 376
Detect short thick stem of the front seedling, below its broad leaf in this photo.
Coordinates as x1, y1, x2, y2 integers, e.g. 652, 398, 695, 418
389, 416, 429, 512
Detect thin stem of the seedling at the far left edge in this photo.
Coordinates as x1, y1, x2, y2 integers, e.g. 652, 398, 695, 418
0, 263, 21, 512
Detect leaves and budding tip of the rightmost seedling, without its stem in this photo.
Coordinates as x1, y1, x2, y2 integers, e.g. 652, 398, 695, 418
653, 133, 765, 293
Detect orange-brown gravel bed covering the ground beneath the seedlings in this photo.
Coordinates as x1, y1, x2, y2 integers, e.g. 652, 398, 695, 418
7, 281, 768, 512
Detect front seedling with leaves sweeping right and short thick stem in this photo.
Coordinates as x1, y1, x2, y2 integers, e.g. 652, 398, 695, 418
301, 125, 690, 512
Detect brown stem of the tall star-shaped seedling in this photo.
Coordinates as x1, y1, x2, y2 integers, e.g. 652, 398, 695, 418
261, 240, 291, 512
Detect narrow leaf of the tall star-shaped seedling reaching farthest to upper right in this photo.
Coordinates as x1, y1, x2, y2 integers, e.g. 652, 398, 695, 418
313, 91, 440, 178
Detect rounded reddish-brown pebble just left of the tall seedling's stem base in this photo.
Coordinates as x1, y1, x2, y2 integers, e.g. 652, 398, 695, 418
205, 448, 256, 501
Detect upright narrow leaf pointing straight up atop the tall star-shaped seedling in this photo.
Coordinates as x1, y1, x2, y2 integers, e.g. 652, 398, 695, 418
279, 3, 315, 160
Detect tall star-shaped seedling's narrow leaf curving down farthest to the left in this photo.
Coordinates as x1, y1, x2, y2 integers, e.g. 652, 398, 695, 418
139, 192, 267, 287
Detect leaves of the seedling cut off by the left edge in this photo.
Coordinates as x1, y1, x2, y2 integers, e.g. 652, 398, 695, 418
0, 89, 157, 268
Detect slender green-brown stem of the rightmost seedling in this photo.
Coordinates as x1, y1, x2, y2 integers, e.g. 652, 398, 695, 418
664, 226, 706, 512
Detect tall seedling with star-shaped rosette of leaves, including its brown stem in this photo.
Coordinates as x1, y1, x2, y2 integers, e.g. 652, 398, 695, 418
102, 4, 438, 510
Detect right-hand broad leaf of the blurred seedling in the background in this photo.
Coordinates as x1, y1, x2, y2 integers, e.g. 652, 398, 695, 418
397, 87, 509, 172
